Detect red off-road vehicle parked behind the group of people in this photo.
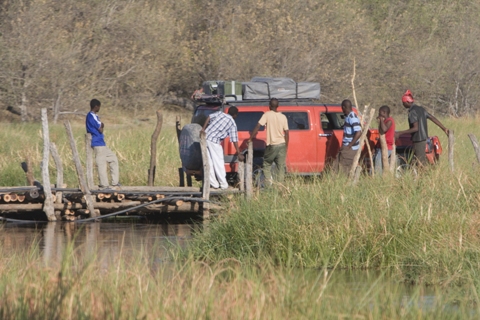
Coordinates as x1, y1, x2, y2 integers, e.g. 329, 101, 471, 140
193, 78, 442, 183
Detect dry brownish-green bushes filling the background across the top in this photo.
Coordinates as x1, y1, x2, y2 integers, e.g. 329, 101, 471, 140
0, 0, 480, 118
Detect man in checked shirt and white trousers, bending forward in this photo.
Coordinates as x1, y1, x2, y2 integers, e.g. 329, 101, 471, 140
202, 107, 244, 189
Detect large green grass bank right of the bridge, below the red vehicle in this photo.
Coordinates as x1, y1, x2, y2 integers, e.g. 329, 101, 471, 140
189, 114, 480, 283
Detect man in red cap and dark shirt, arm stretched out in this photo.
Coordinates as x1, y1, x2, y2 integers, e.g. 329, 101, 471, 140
395, 90, 449, 164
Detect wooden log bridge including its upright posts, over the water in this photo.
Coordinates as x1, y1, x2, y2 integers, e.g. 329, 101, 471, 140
0, 109, 253, 221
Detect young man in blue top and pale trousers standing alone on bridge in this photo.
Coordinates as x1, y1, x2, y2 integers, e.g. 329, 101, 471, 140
86, 99, 120, 189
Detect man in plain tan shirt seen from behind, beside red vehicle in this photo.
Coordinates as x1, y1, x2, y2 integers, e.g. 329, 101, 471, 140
248, 98, 288, 183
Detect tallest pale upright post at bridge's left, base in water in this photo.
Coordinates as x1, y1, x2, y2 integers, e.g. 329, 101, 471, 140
42, 108, 57, 221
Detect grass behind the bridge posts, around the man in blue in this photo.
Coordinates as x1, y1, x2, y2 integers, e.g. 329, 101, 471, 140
0, 109, 191, 187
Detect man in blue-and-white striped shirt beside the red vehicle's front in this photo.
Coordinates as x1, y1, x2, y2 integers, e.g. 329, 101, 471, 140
336, 100, 362, 174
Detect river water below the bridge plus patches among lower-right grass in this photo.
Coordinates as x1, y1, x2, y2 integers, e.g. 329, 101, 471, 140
0, 220, 472, 318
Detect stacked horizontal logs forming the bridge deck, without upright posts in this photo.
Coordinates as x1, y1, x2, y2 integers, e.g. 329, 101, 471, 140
0, 186, 236, 221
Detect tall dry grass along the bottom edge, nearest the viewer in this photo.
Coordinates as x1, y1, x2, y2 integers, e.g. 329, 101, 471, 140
0, 236, 479, 319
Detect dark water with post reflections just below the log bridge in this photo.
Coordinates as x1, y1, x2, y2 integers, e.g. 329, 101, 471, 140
0, 222, 198, 267
